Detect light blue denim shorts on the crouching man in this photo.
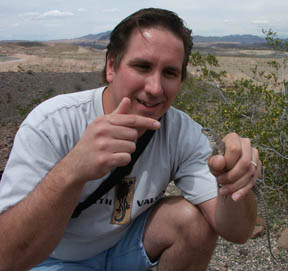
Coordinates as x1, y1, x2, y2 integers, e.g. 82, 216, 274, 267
31, 208, 157, 271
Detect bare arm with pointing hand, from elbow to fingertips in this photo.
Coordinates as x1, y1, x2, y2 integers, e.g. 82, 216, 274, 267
0, 98, 160, 271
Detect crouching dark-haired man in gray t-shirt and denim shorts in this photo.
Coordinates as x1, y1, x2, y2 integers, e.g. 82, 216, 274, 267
0, 9, 261, 270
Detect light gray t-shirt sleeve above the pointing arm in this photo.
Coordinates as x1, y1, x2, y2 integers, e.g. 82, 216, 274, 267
0, 124, 61, 215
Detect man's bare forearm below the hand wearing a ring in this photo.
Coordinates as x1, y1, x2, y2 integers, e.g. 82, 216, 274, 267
216, 191, 257, 243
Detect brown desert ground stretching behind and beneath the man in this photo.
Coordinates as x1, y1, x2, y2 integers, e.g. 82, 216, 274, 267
0, 42, 288, 271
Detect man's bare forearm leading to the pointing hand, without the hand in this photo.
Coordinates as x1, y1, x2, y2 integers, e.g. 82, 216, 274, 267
0, 161, 84, 271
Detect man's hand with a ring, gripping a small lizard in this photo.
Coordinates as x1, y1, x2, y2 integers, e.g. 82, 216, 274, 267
208, 133, 262, 201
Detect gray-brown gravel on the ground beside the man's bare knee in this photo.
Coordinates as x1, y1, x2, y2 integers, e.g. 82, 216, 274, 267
166, 183, 288, 271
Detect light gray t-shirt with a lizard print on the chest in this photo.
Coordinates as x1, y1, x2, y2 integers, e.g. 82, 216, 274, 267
0, 87, 217, 260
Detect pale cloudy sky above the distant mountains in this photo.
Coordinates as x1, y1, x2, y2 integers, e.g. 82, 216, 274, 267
0, 0, 288, 40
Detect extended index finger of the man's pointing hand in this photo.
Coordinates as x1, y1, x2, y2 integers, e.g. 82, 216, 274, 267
108, 114, 160, 130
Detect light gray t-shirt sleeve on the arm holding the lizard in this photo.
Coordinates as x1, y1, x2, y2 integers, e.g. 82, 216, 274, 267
174, 122, 218, 205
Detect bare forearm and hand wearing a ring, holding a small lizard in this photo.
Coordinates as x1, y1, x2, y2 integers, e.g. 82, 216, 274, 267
199, 133, 261, 243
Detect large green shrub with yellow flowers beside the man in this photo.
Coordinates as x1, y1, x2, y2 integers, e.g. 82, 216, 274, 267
175, 48, 288, 203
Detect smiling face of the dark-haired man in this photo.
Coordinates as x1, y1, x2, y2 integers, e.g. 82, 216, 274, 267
103, 28, 184, 119
